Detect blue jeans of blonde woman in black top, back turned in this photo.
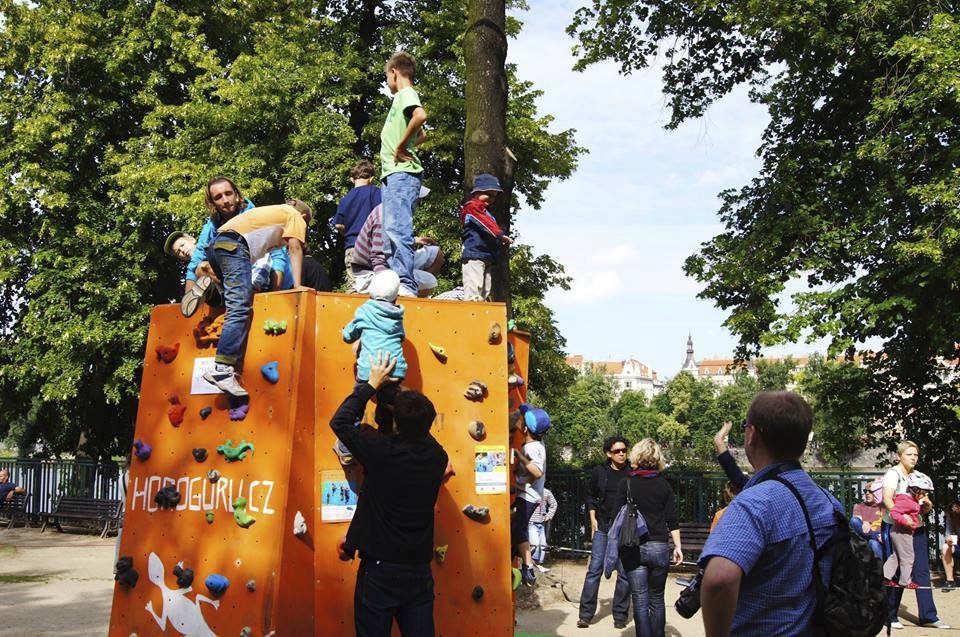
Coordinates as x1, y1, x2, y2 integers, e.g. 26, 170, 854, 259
621, 542, 671, 637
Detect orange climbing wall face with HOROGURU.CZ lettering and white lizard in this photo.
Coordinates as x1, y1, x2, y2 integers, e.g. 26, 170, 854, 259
110, 292, 315, 637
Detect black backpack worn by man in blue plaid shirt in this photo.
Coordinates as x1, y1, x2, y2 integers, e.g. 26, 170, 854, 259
772, 475, 890, 637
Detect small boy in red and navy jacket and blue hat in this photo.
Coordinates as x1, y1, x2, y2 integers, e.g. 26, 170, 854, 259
460, 174, 512, 301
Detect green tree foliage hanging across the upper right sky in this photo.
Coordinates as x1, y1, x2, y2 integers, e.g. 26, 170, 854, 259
569, 0, 960, 472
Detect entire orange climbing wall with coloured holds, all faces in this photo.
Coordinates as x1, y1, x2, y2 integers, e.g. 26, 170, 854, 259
110, 292, 529, 637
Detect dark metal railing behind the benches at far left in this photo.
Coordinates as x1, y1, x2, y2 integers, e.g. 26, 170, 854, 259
0, 458, 123, 520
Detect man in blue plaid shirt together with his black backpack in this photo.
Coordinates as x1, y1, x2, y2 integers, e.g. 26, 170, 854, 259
700, 392, 886, 637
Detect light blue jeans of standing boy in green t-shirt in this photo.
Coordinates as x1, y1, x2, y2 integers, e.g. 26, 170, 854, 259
382, 173, 421, 294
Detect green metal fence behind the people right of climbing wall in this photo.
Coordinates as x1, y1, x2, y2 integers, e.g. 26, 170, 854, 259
546, 470, 960, 570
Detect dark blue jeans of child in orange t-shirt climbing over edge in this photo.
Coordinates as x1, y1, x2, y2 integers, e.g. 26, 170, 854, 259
207, 232, 253, 367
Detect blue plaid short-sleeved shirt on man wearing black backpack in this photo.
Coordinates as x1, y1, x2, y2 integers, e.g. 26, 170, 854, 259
700, 465, 843, 637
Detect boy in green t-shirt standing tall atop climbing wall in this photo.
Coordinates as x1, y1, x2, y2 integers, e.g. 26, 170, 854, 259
380, 51, 427, 296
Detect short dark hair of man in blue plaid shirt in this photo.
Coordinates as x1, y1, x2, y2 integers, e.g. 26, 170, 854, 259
747, 391, 813, 460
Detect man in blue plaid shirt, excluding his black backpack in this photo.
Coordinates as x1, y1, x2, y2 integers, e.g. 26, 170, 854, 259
700, 392, 842, 637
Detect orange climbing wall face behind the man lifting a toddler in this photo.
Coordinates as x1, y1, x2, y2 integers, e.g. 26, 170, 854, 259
314, 294, 513, 637
